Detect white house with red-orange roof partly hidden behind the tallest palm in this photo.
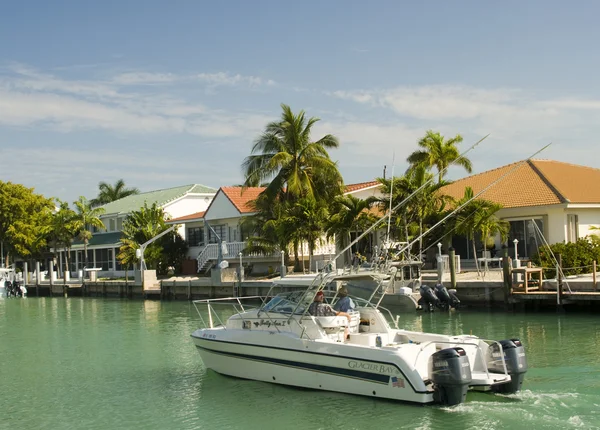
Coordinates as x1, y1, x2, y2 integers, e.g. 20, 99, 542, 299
169, 181, 381, 272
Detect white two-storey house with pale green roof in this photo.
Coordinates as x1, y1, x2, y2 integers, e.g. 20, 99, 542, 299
57, 184, 217, 277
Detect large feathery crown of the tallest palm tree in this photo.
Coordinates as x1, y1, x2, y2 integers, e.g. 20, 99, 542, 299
242, 104, 343, 205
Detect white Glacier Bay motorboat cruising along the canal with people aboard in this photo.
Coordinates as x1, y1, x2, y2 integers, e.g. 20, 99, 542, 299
191, 275, 527, 405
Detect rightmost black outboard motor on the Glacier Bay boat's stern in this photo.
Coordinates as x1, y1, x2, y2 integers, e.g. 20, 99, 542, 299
487, 339, 527, 394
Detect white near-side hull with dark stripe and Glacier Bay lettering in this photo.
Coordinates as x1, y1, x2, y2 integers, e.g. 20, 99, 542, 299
192, 329, 434, 404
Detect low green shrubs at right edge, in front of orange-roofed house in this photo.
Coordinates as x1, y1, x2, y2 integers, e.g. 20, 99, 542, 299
531, 237, 600, 278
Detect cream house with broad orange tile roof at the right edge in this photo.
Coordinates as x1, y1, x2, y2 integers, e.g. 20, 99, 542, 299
442, 160, 600, 258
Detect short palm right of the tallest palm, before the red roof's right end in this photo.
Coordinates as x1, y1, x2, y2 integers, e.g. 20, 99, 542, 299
326, 195, 377, 262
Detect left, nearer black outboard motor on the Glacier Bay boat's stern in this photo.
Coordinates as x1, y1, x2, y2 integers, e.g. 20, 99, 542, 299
429, 347, 473, 406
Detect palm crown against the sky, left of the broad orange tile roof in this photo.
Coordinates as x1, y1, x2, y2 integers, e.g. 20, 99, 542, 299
407, 130, 473, 183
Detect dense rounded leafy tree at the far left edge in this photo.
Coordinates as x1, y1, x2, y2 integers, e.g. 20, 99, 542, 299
0, 181, 54, 266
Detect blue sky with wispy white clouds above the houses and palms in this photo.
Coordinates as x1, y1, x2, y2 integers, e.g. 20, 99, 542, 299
0, 0, 600, 202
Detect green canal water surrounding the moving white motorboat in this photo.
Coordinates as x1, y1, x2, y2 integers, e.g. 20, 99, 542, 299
0, 297, 600, 430
